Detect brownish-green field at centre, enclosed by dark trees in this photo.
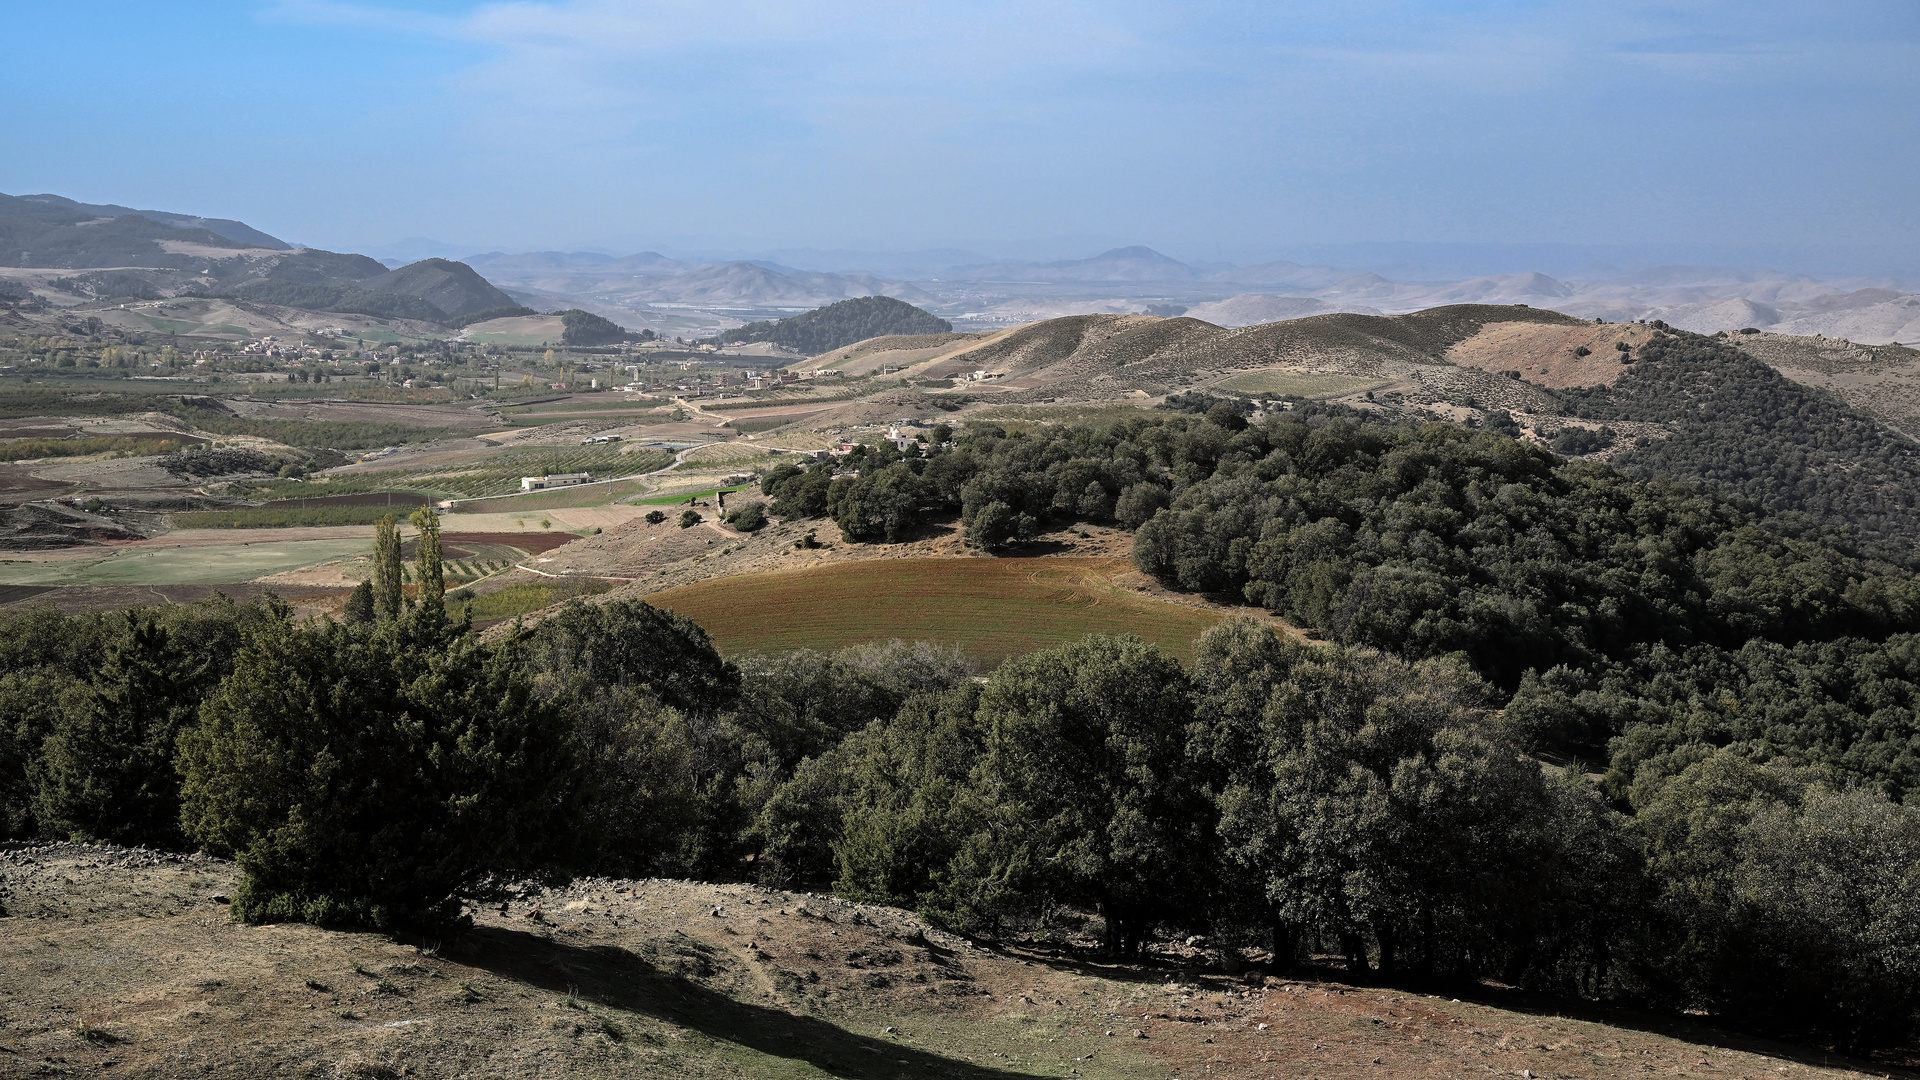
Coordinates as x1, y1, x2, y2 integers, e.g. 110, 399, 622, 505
647, 557, 1221, 663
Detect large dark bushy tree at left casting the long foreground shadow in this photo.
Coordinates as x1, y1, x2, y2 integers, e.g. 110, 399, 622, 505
180, 605, 580, 928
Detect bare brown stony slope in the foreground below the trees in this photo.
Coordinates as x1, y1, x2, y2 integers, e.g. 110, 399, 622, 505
0, 844, 1889, 1080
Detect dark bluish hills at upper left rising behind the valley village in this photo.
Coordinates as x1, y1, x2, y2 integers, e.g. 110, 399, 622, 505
0, 194, 515, 323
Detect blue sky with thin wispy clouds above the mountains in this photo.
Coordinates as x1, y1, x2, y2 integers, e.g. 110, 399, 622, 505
0, 0, 1920, 275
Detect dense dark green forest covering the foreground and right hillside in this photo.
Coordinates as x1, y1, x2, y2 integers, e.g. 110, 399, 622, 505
11, 330, 1920, 1049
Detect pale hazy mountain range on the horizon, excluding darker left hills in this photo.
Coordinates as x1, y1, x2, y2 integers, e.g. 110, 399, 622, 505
453, 246, 1920, 342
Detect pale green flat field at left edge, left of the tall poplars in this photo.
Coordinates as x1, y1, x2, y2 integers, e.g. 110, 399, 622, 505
0, 540, 371, 584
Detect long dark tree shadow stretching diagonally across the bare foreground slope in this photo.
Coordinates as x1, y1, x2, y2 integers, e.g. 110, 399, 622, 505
463, 914, 1031, 1080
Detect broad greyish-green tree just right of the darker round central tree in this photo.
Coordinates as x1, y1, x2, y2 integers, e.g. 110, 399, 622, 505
1194, 621, 1582, 974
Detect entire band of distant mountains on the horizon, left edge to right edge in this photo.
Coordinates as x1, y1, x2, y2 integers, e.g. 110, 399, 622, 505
11, 194, 1920, 344
